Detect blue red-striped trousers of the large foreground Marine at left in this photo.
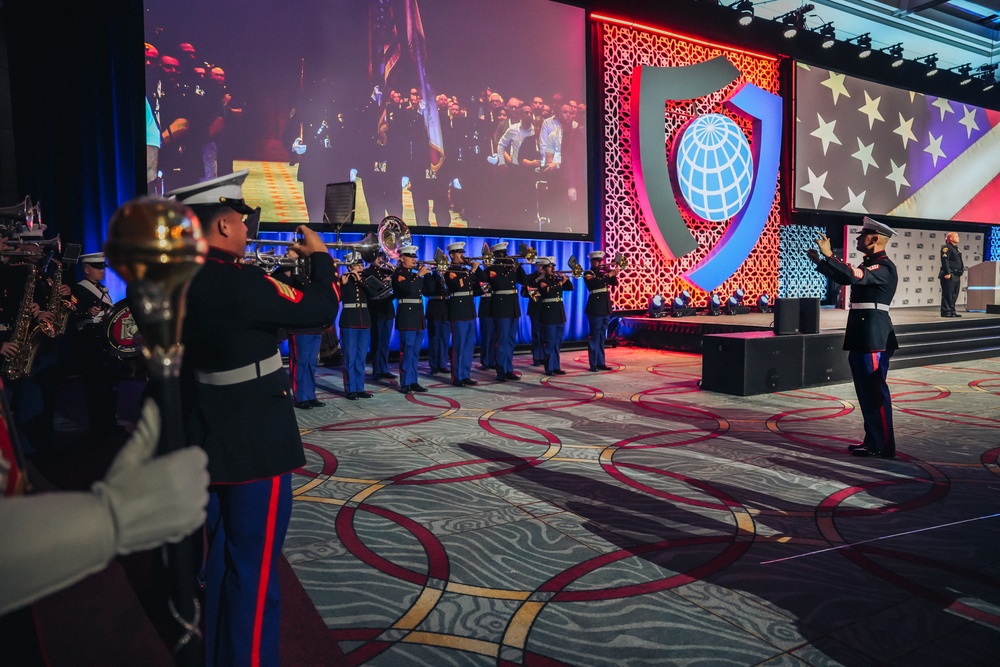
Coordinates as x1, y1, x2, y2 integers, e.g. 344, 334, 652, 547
205, 473, 292, 667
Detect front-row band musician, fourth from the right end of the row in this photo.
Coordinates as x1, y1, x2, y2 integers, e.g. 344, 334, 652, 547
444, 241, 484, 387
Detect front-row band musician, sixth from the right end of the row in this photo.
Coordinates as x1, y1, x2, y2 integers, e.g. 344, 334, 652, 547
340, 252, 375, 401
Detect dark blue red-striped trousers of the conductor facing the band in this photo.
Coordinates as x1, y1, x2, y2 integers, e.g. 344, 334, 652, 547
847, 351, 896, 454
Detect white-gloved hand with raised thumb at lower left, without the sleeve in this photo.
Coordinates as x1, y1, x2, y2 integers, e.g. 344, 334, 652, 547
91, 401, 208, 554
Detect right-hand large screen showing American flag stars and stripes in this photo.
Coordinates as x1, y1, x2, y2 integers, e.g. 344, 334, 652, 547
794, 63, 1000, 223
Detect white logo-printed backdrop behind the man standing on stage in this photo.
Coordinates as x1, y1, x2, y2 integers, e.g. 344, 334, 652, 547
844, 225, 984, 308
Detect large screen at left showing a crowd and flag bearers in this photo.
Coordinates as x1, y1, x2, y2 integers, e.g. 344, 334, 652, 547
145, 0, 590, 238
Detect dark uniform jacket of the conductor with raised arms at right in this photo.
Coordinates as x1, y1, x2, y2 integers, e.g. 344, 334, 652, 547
816, 251, 899, 352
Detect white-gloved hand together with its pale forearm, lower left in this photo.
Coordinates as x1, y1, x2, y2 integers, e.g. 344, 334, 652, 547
0, 401, 208, 615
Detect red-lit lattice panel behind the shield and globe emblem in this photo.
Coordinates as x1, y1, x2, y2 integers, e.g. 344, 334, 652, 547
595, 19, 781, 310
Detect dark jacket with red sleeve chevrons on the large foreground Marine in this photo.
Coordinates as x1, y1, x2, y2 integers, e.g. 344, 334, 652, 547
182, 248, 338, 483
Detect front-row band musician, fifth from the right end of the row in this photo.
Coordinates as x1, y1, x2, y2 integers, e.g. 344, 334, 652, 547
392, 245, 436, 394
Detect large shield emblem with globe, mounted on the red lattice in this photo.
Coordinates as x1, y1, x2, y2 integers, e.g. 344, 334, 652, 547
630, 56, 782, 292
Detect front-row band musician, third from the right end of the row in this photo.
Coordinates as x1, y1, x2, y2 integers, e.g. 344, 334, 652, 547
480, 241, 528, 382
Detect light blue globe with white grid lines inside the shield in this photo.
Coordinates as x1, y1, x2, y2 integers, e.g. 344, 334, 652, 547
674, 114, 753, 222
